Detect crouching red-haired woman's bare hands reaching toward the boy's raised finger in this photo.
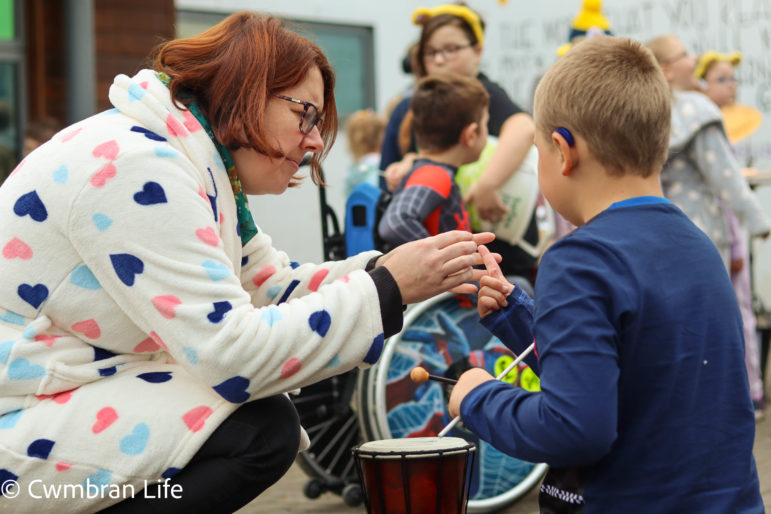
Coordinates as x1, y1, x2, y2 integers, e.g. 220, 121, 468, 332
377, 230, 500, 304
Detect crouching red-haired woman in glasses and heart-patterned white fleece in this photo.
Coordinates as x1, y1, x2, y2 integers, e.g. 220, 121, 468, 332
0, 12, 492, 512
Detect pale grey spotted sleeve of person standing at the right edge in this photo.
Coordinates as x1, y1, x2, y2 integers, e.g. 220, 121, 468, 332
690, 124, 771, 236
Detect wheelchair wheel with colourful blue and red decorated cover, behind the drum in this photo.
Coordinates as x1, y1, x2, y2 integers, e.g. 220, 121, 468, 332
357, 293, 547, 512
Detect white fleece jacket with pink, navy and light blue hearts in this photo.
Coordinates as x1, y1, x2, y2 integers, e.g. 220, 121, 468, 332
0, 70, 383, 513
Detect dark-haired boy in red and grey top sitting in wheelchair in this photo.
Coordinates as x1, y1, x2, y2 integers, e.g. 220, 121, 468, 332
378, 75, 490, 246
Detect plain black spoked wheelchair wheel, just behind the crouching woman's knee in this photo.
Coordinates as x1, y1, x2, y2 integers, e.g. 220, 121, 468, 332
292, 370, 362, 506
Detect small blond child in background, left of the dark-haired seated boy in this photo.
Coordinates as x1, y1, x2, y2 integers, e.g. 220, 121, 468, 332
345, 109, 385, 197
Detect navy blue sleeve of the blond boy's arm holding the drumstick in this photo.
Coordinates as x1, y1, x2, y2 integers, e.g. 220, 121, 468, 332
460, 238, 624, 466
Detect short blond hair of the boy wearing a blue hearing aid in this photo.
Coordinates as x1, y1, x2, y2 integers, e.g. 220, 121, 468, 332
533, 36, 672, 177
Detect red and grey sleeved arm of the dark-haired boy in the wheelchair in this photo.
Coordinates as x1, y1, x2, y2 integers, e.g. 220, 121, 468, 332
378, 166, 452, 246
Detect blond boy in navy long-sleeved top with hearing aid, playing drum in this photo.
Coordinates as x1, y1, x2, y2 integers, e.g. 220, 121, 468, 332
450, 36, 763, 508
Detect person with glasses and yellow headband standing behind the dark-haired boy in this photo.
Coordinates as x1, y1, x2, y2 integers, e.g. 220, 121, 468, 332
380, 4, 538, 278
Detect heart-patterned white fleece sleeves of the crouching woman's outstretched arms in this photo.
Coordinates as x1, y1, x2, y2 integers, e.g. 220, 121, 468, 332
66, 156, 384, 403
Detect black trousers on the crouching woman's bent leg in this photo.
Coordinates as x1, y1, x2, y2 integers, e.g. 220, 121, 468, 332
102, 395, 300, 514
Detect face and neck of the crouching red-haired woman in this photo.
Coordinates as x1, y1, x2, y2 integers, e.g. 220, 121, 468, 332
232, 67, 324, 195
